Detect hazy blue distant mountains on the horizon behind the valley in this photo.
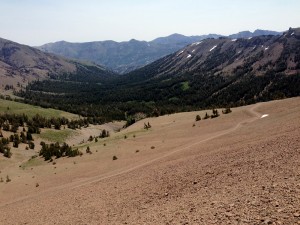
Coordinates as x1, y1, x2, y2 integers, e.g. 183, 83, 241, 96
37, 30, 281, 74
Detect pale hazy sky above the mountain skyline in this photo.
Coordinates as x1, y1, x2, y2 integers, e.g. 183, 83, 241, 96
0, 0, 300, 45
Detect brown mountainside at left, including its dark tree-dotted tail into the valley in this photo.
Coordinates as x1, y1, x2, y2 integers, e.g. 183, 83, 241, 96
0, 38, 116, 89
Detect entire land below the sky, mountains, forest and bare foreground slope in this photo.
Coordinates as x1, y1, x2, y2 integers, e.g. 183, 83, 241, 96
0, 23, 300, 225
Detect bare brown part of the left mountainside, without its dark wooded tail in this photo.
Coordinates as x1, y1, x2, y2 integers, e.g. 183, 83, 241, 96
0, 38, 76, 89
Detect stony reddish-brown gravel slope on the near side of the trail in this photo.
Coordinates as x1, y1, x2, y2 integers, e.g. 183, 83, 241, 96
0, 98, 300, 224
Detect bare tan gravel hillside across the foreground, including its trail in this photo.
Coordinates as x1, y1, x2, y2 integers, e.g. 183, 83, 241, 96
0, 98, 300, 224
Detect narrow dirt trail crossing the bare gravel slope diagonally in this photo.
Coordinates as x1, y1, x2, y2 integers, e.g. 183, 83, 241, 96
0, 103, 262, 208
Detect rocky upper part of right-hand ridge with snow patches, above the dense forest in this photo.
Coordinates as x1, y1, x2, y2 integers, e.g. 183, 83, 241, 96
127, 29, 300, 80
